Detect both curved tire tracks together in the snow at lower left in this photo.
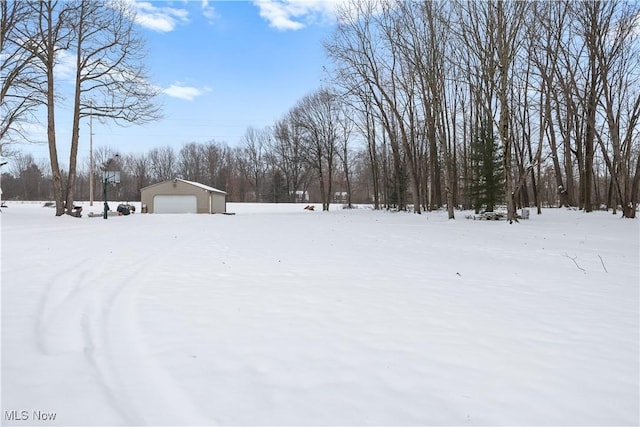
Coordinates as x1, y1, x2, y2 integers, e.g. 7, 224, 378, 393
36, 254, 211, 425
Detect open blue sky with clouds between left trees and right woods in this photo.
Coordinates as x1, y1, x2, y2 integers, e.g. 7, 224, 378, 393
20, 0, 338, 164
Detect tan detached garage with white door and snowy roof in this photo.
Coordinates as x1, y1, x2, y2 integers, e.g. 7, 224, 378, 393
140, 178, 227, 213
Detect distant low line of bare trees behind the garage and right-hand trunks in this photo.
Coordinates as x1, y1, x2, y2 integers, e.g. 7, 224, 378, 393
1, 121, 624, 214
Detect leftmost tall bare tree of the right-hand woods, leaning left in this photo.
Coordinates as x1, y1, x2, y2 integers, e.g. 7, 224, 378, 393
325, 0, 412, 212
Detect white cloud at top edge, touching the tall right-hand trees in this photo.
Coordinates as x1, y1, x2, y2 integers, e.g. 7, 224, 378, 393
253, 0, 340, 31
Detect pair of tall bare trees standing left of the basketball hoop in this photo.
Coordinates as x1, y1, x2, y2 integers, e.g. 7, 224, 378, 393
15, 0, 158, 215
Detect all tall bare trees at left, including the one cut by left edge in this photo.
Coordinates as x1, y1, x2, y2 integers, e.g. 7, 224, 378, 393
0, 0, 159, 215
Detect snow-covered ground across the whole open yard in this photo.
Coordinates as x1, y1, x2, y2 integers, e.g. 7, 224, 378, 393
0, 202, 640, 426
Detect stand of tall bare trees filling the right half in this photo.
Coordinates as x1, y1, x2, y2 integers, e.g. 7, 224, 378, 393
326, 0, 640, 220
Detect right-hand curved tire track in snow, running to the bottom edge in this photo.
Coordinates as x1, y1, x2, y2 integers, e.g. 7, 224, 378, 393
85, 256, 210, 425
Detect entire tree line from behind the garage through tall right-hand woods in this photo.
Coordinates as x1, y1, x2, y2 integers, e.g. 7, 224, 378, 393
3, 0, 640, 220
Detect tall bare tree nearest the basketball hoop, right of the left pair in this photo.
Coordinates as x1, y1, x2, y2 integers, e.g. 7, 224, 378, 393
66, 0, 160, 213
